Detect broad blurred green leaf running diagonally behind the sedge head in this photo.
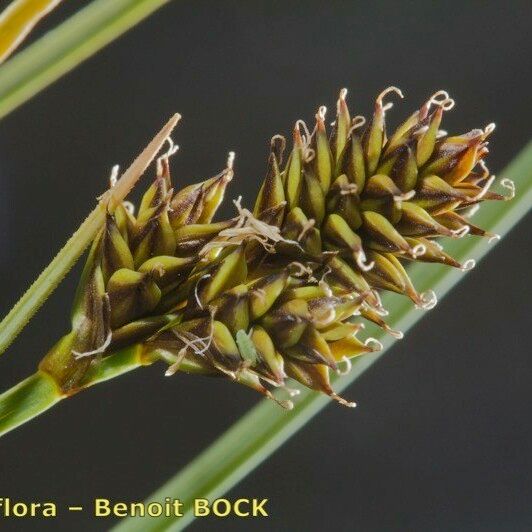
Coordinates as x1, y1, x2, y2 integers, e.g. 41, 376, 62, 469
113, 139, 532, 532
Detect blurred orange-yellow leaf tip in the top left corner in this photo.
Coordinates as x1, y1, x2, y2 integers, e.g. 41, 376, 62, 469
0, 0, 61, 63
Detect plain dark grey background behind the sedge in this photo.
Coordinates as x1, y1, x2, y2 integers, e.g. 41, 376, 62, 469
0, 0, 532, 531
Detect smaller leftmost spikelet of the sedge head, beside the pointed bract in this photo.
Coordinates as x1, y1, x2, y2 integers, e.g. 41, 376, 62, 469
39, 152, 233, 393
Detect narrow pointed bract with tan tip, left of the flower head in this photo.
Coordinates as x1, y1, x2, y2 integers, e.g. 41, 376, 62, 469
0, 114, 180, 354
